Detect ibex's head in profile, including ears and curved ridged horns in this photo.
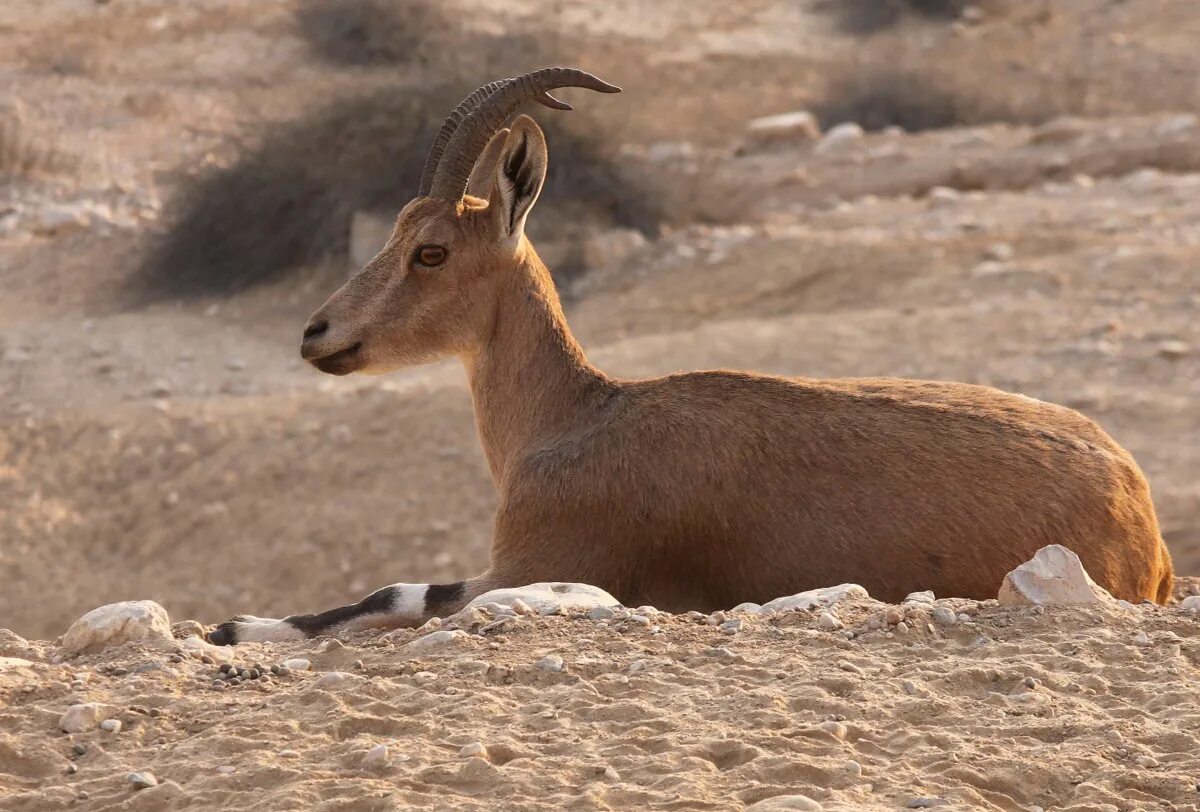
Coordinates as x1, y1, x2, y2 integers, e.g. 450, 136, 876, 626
300, 67, 620, 375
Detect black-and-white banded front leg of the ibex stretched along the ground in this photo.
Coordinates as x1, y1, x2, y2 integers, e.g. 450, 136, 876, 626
209, 575, 504, 645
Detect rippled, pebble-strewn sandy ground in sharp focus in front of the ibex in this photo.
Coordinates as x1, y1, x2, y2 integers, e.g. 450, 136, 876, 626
7, 590, 1200, 812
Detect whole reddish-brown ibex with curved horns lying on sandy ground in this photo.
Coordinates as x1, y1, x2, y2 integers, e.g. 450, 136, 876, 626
211, 68, 1171, 643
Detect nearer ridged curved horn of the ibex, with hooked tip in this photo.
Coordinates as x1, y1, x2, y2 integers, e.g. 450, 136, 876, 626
428, 67, 620, 200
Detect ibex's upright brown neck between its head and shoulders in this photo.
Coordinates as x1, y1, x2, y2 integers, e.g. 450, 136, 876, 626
463, 246, 614, 487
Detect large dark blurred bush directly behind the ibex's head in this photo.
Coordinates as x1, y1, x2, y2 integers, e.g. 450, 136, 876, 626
131, 85, 661, 299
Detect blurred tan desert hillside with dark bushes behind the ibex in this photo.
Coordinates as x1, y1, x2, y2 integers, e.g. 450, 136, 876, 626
0, 0, 1200, 637
